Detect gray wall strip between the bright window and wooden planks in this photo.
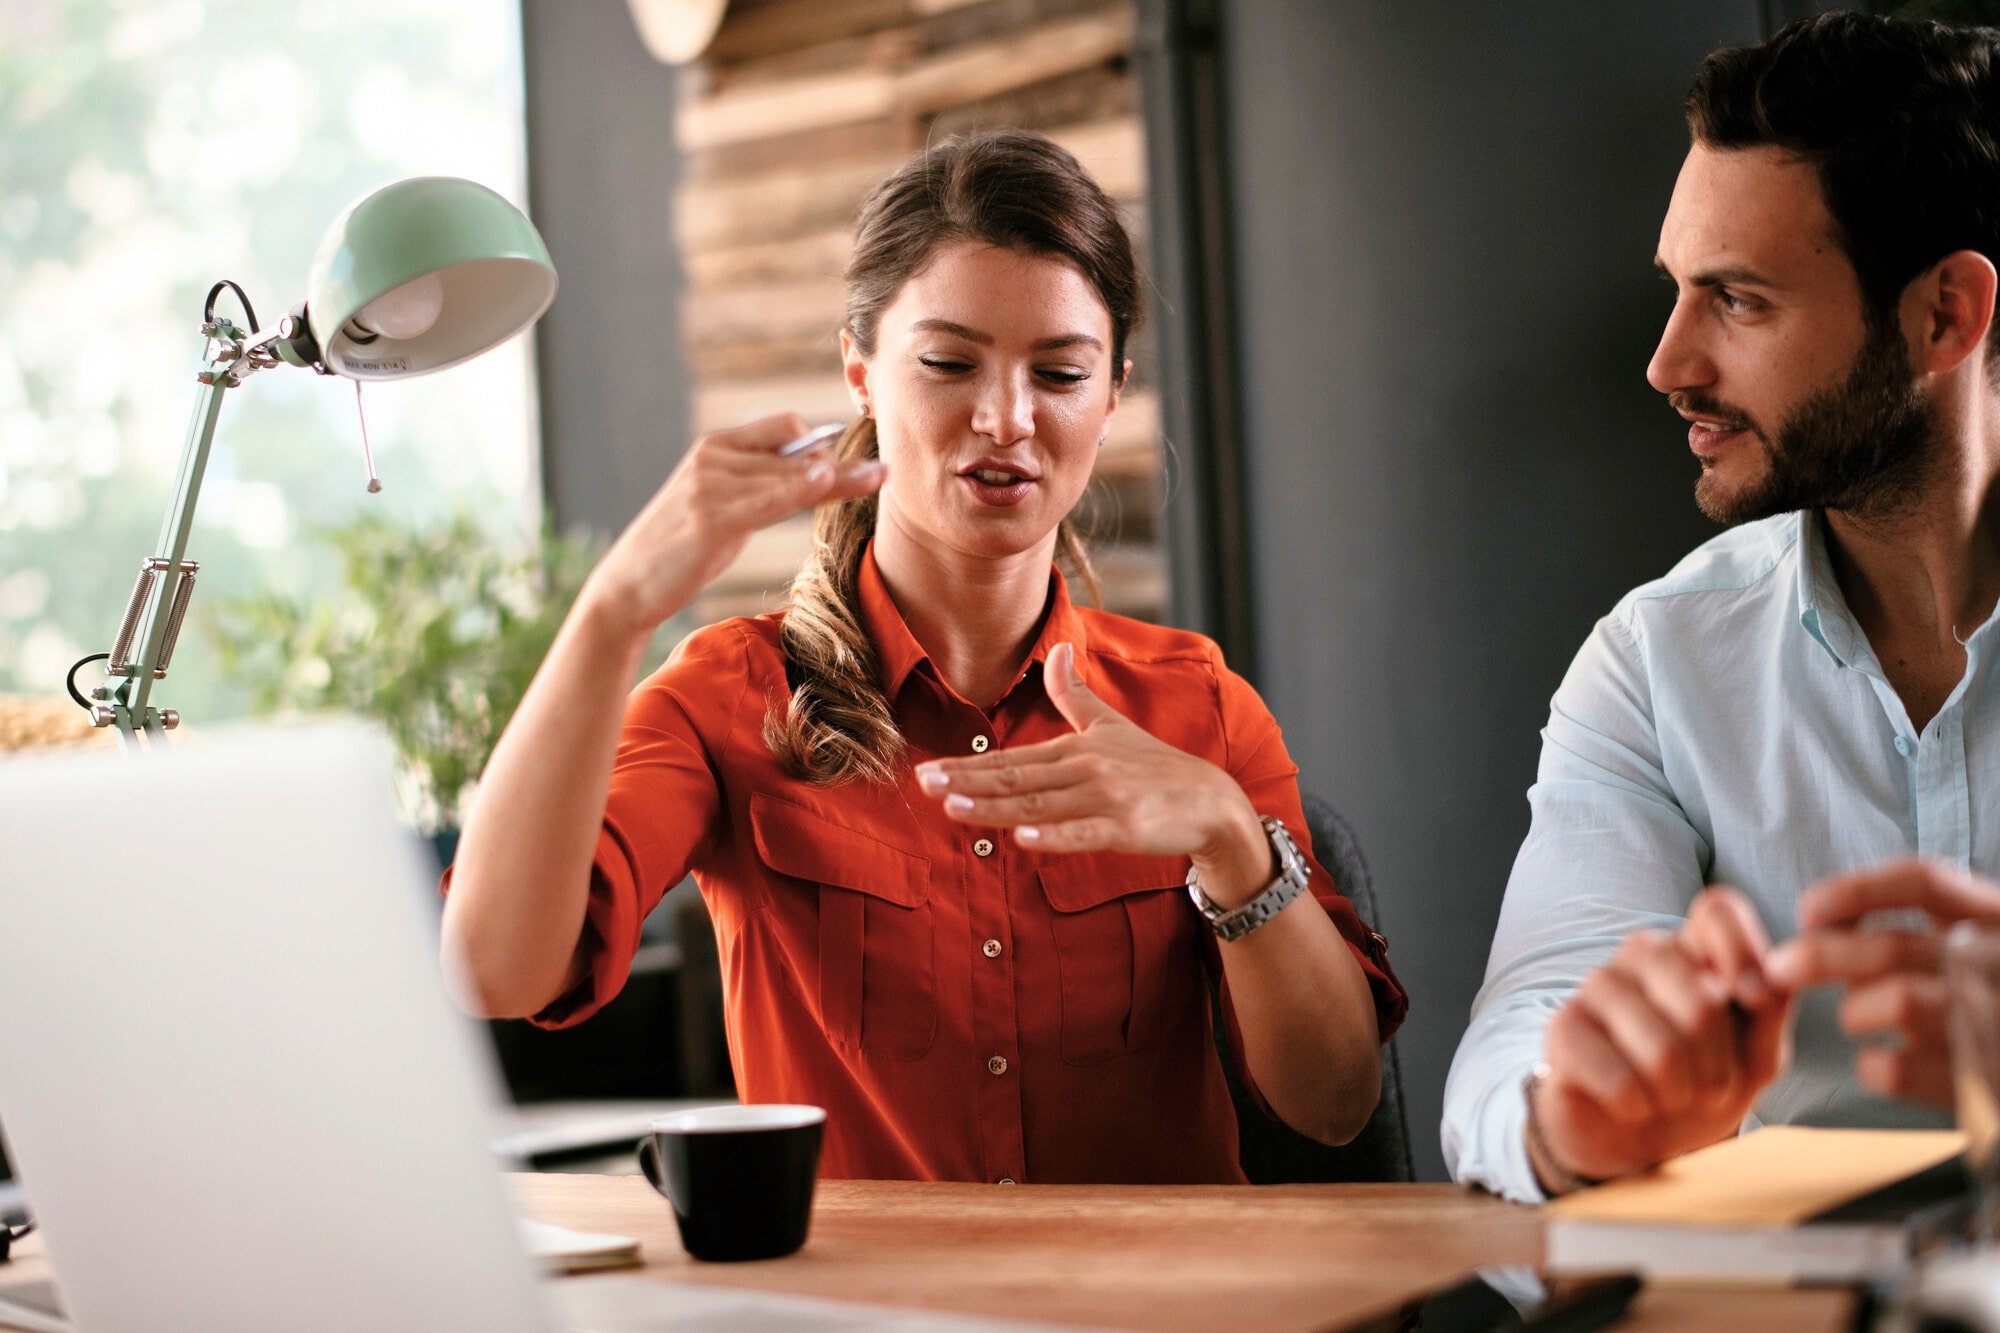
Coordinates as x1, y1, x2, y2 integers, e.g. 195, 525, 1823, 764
522, 0, 688, 534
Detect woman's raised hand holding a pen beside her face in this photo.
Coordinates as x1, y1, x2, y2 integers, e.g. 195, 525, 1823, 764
584, 412, 888, 634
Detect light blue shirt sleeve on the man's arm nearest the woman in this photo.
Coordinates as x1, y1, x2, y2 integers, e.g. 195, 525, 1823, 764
1440, 608, 1712, 1201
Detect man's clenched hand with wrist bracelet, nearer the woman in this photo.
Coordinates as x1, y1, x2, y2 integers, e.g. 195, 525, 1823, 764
1528, 887, 1792, 1187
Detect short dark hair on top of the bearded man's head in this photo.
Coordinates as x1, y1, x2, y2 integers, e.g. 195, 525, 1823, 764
1688, 14, 2000, 326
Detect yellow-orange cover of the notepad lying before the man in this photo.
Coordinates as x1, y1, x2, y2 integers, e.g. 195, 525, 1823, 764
1542, 1125, 1966, 1227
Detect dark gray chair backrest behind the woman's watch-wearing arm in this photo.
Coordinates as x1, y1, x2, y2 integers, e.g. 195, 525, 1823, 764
1216, 795, 1416, 1185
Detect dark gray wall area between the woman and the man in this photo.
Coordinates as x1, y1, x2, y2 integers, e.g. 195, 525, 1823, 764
1226, 0, 1758, 1179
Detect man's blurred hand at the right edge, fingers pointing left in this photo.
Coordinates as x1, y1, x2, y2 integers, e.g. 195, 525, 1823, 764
1766, 859, 2000, 1107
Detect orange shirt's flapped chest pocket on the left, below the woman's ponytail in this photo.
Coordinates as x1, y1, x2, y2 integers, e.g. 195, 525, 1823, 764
750, 793, 938, 1061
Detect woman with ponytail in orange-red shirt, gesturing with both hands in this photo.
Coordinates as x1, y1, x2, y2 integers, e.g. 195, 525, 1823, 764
444, 132, 1406, 1181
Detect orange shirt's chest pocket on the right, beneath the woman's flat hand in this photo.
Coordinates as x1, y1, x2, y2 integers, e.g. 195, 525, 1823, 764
1040, 853, 1204, 1065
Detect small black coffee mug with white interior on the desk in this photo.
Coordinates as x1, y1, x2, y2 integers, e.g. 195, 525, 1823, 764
638, 1105, 826, 1263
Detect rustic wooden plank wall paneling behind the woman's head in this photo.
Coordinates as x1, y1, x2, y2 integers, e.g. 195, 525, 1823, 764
674, 0, 1166, 620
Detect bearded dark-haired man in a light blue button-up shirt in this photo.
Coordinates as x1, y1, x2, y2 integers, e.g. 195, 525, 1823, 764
1444, 14, 2000, 1199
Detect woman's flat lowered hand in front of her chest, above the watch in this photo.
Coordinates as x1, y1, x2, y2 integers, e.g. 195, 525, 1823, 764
916, 642, 1272, 907
